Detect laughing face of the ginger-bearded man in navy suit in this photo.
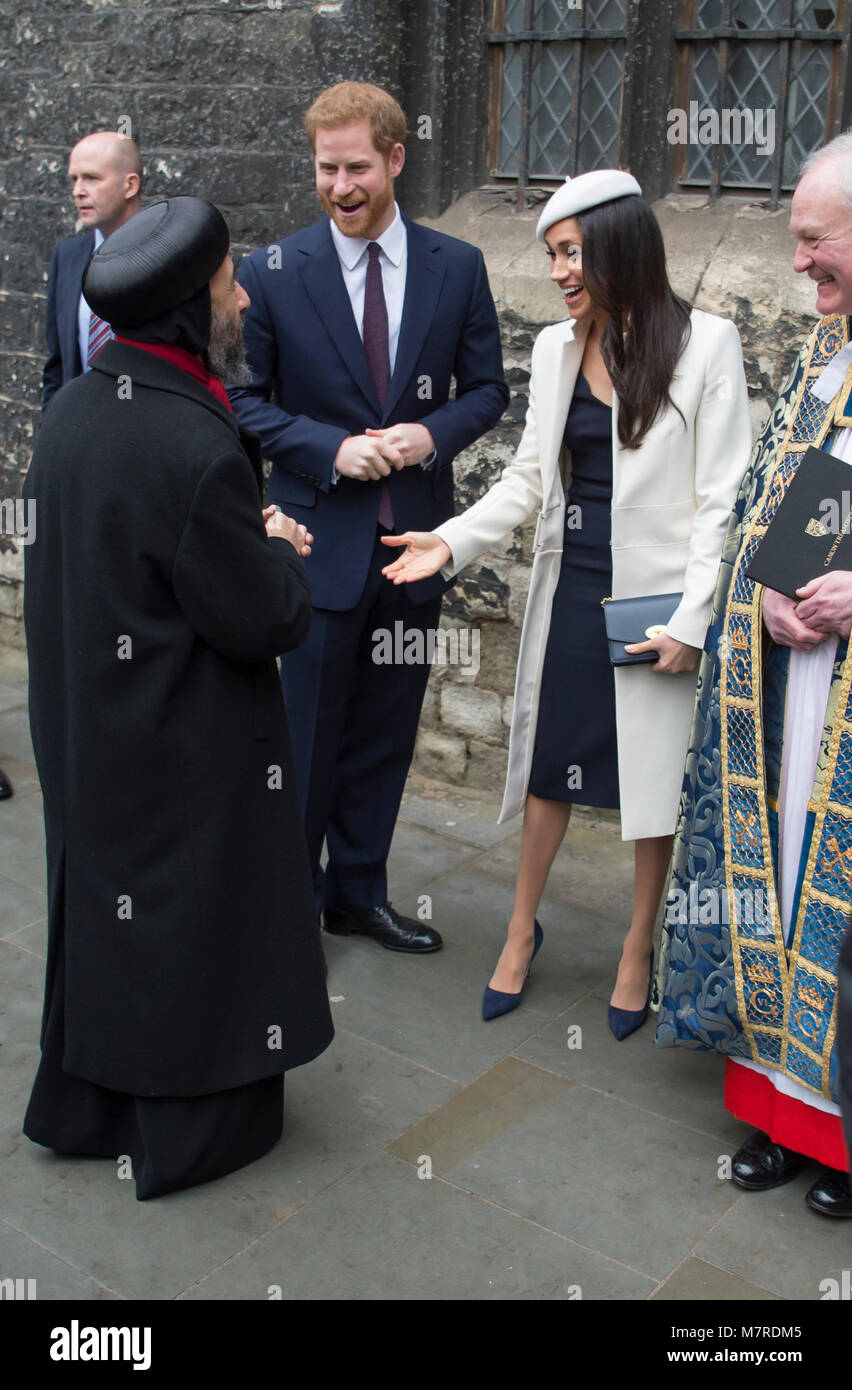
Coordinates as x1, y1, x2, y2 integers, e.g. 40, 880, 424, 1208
314, 121, 406, 240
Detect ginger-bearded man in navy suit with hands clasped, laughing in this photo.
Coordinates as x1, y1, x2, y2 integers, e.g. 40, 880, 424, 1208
231, 82, 509, 952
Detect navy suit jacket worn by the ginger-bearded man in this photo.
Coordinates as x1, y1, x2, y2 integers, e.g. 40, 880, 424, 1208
229, 217, 509, 612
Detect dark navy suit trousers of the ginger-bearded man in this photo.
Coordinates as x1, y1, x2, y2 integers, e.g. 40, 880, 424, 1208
281, 530, 441, 912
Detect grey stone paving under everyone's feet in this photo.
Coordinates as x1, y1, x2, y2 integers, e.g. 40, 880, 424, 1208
0, 651, 851, 1300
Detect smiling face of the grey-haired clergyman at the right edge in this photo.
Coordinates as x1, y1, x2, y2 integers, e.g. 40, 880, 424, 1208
789, 160, 852, 314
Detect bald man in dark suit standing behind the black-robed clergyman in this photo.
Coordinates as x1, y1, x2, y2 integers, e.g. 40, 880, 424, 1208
42, 131, 142, 407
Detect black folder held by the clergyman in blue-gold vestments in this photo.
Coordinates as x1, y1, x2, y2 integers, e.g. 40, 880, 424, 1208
746, 448, 852, 599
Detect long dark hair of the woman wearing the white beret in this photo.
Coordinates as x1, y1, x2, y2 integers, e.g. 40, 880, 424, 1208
577, 196, 689, 449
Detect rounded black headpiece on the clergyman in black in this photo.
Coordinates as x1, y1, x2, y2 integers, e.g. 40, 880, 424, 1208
83, 196, 231, 353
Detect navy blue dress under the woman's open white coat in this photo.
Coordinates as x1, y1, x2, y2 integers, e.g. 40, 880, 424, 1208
530, 373, 618, 809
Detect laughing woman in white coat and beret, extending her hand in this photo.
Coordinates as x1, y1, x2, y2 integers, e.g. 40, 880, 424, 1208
384, 170, 751, 1038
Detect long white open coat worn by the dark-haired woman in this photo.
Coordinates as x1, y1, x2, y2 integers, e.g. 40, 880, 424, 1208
438, 309, 752, 840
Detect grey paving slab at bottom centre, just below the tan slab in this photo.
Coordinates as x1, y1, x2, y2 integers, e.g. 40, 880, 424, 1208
180, 1155, 653, 1302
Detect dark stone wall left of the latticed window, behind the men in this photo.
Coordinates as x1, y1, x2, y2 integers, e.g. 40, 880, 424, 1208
0, 0, 488, 645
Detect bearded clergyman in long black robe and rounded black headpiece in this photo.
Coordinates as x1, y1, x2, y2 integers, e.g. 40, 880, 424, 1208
24, 197, 332, 1200
